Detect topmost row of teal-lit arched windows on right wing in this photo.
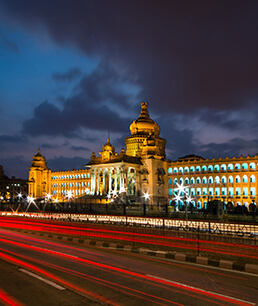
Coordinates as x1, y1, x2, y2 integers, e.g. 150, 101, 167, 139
168, 163, 258, 174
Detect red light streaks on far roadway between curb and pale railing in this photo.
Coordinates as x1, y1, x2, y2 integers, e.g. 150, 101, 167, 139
0, 218, 258, 260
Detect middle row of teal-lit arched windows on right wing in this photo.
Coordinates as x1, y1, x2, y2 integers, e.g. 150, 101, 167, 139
168, 175, 256, 185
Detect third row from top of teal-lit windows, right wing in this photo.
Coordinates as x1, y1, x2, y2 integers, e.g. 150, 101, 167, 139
168, 187, 257, 197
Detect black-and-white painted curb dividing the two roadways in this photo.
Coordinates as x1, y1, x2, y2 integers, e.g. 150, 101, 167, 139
20, 230, 258, 274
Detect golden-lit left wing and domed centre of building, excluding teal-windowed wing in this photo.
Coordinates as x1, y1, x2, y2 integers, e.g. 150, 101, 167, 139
29, 102, 168, 203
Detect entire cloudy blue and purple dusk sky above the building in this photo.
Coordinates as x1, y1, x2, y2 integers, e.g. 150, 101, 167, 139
0, 0, 258, 178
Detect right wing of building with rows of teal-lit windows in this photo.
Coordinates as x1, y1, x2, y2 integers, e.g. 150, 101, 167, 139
168, 155, 258, 209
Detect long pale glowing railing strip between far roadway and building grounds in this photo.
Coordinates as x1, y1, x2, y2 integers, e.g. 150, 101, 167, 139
0, 211, 258, 238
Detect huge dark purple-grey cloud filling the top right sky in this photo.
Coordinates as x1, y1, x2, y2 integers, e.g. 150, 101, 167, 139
3, 0, 258, 113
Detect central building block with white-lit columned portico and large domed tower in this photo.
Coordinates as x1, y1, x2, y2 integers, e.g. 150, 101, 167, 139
87, 102, 168, 203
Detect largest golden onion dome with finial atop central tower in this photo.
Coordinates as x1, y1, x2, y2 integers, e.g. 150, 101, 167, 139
130, 102, 160, 137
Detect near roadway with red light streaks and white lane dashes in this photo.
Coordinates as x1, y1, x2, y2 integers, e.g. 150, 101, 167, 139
0, 229, 258, 306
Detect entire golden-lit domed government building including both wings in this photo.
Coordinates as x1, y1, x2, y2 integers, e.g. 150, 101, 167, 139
28, 102, 258, 209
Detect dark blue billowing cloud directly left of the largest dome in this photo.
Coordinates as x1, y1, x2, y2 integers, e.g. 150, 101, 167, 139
23, 63, 139, 137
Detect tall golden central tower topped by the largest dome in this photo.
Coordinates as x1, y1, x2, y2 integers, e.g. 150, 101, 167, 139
125, 102, 168, 204
